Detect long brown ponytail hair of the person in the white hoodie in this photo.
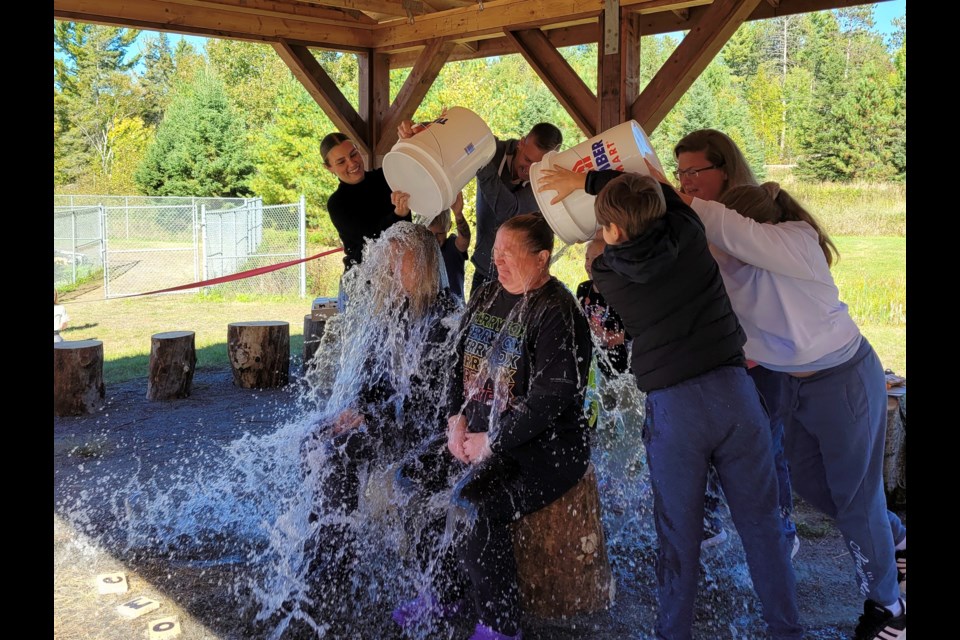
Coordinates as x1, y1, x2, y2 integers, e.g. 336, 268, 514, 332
720, 182, 840, 266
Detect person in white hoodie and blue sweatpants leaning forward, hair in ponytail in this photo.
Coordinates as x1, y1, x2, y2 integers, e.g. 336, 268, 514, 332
684, 182, 907, 640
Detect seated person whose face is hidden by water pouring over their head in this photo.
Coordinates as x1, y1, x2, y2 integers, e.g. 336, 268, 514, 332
302, 222, 459, 577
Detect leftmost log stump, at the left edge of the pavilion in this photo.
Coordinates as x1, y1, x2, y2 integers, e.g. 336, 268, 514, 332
53, 340, 106, 416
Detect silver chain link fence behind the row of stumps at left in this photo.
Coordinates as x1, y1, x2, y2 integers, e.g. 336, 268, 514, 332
54, 196, 306, 298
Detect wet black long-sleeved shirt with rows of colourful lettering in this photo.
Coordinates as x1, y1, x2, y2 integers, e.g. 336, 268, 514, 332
448, 278, 592, 473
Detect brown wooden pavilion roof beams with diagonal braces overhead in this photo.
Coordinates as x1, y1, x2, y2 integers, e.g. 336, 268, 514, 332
53, 0, 892, 165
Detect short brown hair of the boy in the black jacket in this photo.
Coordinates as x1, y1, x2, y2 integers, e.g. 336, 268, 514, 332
594, 173, 667, 239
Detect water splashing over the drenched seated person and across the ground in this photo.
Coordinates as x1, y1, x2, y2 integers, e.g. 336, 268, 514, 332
48, 223, 776, 639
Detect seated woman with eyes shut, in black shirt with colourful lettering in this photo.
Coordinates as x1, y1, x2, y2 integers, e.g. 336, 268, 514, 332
394, 214, 591, 640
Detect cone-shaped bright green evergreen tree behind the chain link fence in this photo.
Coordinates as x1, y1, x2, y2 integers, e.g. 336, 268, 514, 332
135, 70, 253, 197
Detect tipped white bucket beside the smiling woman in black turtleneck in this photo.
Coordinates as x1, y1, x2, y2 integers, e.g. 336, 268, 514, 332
383, 107, 497, 224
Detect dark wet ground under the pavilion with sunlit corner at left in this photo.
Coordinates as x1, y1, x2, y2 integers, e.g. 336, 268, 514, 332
54, 370, 906, 640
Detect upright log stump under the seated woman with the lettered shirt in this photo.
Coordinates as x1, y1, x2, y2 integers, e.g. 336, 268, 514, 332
513, 465, 616, 618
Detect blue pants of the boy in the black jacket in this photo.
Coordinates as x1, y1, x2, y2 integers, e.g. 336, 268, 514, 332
643, 367, 803, 640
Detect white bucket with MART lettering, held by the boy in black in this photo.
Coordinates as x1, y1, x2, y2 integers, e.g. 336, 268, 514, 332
530, 120, 664, 244
